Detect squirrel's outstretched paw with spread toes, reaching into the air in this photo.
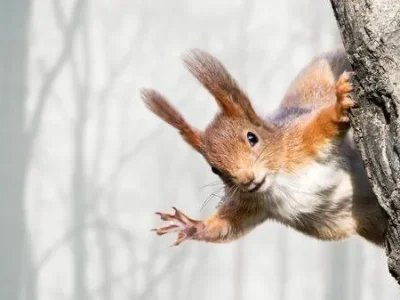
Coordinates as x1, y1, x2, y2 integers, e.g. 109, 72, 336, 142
152, 207, 204, 246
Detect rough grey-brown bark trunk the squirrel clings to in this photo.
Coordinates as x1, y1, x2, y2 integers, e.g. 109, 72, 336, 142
331, 0, 400, 283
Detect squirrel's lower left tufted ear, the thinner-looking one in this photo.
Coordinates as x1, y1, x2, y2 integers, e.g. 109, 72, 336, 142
141, 89, 203, 152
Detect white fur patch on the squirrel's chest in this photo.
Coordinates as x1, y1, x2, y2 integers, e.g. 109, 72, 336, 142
265, 161, 353, 220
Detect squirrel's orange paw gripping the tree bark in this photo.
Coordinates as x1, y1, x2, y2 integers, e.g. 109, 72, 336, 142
335, 72, 356, 123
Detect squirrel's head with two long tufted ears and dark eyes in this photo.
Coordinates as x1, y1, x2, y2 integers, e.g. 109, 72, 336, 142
142, 50, 282, 192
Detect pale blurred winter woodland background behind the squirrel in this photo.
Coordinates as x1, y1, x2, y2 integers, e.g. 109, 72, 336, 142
0, 0, 398, 300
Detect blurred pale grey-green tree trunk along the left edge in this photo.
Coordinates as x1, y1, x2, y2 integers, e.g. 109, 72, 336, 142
0, 0, 30, 300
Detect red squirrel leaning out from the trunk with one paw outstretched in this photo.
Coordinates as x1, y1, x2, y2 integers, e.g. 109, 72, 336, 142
142, 49, 387, 246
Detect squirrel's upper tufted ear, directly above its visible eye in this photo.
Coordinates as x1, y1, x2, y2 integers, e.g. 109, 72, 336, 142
183, 49, 264, 125
